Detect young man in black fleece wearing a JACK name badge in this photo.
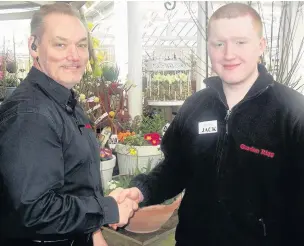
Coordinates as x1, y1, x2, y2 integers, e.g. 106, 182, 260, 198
115, 3, 304, 246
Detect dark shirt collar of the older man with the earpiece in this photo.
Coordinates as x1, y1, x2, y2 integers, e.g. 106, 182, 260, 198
27, 67, 75, 107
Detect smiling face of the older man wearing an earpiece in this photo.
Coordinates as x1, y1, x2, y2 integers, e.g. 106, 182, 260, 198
30, 14, 89, 89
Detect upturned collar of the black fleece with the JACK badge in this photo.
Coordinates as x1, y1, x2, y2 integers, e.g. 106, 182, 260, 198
204, 64, 274, 101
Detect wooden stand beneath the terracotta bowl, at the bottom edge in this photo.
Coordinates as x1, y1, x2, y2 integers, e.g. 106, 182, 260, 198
102, 211, 178, 246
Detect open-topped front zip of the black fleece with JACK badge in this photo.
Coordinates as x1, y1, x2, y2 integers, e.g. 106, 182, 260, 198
216, 85, 270, 176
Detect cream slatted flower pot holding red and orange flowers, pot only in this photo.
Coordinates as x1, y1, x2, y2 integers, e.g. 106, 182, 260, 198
115, 144, 162, 174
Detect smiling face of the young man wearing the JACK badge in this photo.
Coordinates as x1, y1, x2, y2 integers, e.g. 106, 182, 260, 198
208, 15, 266, 84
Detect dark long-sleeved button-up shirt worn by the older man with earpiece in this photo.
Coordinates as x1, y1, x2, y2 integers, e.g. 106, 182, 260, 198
0, 68, 119, 240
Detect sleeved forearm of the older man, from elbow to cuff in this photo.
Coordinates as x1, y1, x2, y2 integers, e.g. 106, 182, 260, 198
18, 192, 119, 235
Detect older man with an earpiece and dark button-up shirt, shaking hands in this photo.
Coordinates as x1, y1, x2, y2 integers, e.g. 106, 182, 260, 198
0, 3, 138, 246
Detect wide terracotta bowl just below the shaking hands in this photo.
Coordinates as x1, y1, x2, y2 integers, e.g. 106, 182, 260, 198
125, 196, 182, 233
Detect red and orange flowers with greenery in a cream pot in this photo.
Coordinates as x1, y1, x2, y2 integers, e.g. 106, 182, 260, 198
115, 114, 166, 174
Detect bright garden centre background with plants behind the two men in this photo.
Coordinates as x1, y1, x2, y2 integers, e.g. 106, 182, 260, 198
0, 0, 304, 246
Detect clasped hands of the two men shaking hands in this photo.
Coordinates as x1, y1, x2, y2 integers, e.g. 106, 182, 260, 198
109, 187, 144, 230
